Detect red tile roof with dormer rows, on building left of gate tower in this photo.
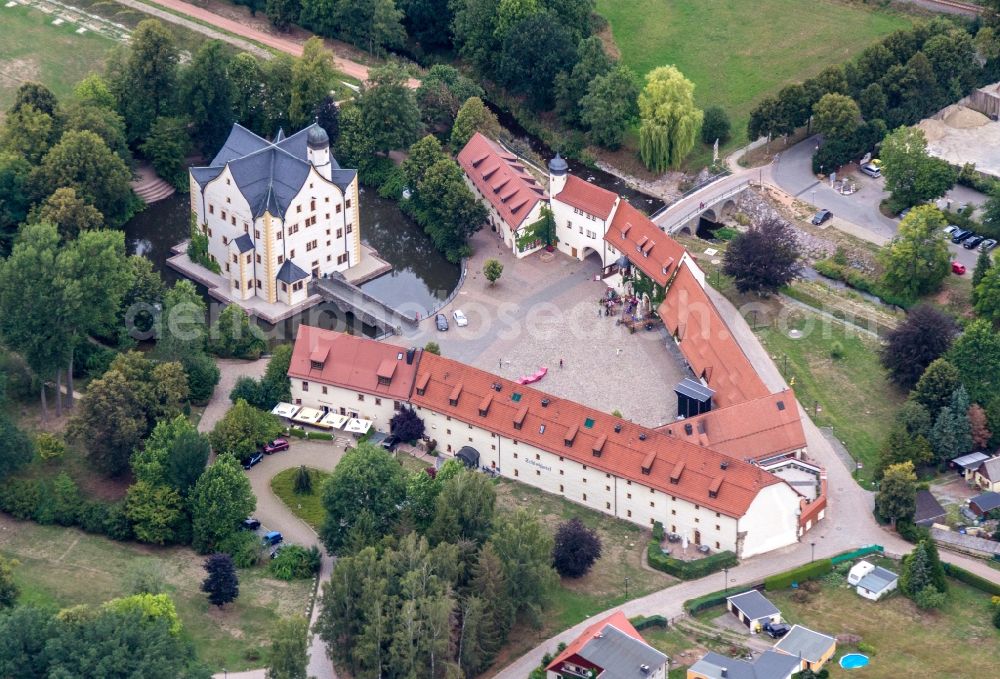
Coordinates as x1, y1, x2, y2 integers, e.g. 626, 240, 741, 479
458, 132, 549, 230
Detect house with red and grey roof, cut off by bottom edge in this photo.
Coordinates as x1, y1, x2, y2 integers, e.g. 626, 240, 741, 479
545, 611, 670, 679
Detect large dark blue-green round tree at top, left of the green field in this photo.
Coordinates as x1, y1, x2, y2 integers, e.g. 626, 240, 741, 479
497, 11, 577, 111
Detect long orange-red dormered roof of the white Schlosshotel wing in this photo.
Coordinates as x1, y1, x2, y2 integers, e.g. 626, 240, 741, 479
410, 352, 781, 517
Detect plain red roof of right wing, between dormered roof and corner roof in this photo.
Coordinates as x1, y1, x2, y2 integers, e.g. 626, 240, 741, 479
657, 265, 770, 408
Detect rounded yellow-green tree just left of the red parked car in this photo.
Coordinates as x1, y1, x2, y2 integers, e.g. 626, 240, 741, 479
879, 205, 951, 299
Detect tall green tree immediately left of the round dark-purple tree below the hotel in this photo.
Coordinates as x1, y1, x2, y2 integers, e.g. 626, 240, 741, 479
491, 509, 557, 624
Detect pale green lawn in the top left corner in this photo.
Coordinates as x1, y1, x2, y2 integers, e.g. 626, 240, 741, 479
0, 3, 115, 115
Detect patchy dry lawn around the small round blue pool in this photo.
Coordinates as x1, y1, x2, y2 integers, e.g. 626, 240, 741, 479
768, 569, 1000, 679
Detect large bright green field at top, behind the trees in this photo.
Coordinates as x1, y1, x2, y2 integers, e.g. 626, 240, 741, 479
597, 0, 911, 145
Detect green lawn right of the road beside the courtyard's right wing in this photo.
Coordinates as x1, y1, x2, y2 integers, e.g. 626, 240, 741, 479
757, 307, 904, 481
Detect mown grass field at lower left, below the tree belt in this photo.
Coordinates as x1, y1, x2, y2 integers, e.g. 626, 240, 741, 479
0, 515, 313, 672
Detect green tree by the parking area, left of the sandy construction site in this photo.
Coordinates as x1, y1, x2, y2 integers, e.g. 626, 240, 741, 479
879, 127, 955, 210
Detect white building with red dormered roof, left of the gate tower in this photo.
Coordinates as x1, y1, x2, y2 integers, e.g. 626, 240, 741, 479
457, 132, 549, 257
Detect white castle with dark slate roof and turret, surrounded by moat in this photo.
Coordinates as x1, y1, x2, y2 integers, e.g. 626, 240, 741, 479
190, 123, 361, 305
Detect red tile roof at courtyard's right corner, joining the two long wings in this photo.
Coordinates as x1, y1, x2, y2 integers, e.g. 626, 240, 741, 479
657, 389, 806, 460
